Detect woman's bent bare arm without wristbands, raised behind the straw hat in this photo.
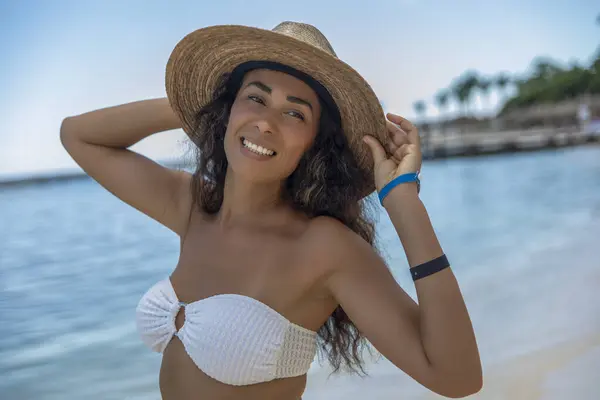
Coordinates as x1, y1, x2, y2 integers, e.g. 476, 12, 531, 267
60, 98, 192, 236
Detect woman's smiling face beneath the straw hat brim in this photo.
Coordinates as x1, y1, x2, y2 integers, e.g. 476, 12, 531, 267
225, 69, 321, 183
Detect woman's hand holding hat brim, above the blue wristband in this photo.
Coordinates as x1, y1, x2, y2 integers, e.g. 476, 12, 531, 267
363, 113, 422, 191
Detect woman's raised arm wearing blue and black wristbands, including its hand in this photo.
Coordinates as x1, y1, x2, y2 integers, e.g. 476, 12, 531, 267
321, 115, 483, 398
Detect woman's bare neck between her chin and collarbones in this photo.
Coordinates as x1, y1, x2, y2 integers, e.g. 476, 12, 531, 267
218, 169, 284, 228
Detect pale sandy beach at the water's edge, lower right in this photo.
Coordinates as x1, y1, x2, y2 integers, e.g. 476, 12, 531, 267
303, 332, 600, 400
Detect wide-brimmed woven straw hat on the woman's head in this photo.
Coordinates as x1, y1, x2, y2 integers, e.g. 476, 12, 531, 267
166, 21, 388, 196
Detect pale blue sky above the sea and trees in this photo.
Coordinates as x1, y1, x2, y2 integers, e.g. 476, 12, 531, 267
0, 0, 600, 177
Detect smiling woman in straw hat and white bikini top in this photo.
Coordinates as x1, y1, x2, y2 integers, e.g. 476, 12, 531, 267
61, 22, 482, 400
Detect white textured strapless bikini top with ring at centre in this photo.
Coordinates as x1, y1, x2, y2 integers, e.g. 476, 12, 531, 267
136, 278, 317, 385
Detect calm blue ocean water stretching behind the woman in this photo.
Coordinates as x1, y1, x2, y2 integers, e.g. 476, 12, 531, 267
0, 146, 600, 400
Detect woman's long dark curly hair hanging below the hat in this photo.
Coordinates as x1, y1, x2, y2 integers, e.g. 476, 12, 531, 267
183, 68, 375, 374
